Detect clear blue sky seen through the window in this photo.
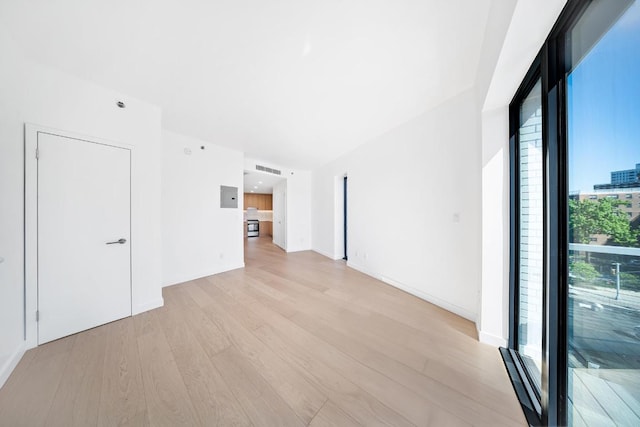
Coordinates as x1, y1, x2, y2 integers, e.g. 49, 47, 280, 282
567, 0, 640, 192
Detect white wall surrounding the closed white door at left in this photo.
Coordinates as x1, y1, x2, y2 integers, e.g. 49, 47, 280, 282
0, 29, 162, 384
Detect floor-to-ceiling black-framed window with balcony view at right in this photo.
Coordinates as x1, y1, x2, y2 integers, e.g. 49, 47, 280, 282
502, 0, 640, 426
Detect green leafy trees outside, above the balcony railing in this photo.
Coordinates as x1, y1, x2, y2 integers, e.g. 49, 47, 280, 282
569, 198, 639, 246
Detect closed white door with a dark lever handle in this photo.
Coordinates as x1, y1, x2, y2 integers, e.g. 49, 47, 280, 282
38, 132, 131, 344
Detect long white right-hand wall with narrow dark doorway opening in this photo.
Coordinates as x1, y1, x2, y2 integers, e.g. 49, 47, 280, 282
312, 90, 481, 320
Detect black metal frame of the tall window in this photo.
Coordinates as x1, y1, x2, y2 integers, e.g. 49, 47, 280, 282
501, 0, 593, 425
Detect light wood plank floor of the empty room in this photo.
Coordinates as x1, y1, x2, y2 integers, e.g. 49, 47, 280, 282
0, 239, 526, 426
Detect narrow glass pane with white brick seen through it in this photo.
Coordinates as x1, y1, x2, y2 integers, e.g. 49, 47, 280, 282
518, 80, 543, 394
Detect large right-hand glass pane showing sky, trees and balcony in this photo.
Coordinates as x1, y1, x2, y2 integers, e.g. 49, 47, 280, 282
567, 0, 640, 426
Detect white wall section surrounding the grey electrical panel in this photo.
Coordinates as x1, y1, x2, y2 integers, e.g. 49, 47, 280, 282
162, 130, 244, 286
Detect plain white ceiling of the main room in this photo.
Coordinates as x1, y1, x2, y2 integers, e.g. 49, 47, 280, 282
0, 0, 491, 169
